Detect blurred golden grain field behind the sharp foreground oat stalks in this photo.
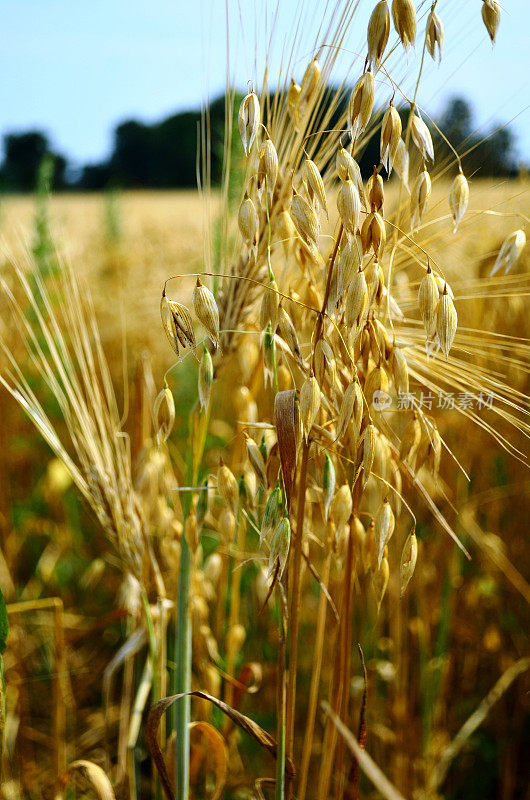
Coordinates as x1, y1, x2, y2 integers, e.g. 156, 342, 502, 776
0, 180, 530, 800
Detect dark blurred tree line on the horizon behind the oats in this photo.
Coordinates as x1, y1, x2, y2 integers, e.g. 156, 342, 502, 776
0, 90, 517, 192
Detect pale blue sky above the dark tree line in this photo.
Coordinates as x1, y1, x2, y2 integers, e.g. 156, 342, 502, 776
0, 0, 530, 163
